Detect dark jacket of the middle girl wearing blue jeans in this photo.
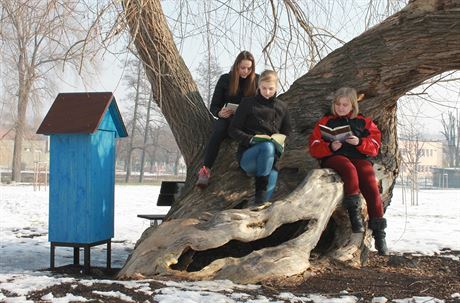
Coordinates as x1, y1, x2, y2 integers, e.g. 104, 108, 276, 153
228, 94, 291, 159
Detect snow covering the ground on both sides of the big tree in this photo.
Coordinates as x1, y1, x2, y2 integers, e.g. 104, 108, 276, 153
0, 185, 460, 303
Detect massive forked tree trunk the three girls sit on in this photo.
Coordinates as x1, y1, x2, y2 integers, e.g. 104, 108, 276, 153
119, 0, 460, 282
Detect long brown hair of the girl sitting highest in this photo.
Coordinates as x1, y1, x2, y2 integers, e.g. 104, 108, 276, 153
230, 51, 257, 97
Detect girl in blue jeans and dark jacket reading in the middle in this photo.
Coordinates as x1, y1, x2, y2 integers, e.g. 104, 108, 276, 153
229, 70, 291, 204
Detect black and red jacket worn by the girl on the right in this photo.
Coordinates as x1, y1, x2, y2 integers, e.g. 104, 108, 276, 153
309, 114, 381, 159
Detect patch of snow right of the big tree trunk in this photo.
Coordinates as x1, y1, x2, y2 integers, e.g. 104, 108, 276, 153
385, 187, 460, 255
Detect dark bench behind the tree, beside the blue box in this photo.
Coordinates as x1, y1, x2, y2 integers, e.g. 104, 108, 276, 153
137, 181, 185, 226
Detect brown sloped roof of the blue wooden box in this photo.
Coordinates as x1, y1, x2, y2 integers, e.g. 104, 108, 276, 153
37, 92, 128, 137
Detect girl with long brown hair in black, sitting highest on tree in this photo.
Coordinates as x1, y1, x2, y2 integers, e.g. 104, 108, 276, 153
196, 51, 257, 189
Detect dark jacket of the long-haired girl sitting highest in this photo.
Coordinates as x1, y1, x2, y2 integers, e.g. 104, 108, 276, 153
209, 73, 259, 117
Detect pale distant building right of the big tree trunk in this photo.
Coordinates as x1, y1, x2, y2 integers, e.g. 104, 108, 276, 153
398, 139, 444, 179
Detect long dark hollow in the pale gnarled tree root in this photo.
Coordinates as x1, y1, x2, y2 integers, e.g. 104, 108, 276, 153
171, 220, 309, 272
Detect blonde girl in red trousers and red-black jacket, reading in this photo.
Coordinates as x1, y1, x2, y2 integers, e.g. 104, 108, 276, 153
309, 87, 388, 255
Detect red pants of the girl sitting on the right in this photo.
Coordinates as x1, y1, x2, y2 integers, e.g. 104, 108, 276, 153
321, 155, 383, 219
